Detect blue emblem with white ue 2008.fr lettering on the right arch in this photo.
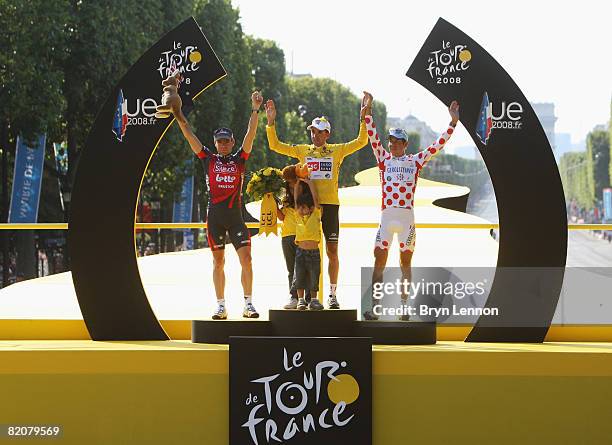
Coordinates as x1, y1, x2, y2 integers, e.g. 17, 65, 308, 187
476, 91, 523, 145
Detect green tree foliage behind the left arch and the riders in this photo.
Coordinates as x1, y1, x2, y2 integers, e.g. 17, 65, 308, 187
0, 0, 386, 221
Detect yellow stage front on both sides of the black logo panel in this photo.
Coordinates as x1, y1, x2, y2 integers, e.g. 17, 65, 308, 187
0, 341, 612, 445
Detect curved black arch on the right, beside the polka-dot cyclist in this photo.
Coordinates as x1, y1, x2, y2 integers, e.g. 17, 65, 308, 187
406, 18, 567, 342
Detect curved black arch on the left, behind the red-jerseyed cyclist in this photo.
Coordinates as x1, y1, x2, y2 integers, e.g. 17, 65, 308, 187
68, 18, 226, 340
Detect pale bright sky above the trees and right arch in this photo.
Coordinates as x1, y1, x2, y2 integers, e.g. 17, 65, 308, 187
232, 0, 612, 145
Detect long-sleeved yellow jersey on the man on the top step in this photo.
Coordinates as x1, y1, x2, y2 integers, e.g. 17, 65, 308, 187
266, 121, 368, 205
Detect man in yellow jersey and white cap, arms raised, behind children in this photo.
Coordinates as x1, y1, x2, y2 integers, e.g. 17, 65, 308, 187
265, 95, 371, 309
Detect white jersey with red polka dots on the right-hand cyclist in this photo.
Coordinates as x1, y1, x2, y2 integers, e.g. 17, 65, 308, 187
365, 116, 454, 210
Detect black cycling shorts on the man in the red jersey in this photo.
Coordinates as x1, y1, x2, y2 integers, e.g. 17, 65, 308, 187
206, 206, 251, 250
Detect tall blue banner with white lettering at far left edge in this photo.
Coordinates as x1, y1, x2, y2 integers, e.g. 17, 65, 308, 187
8, 134, 46, 223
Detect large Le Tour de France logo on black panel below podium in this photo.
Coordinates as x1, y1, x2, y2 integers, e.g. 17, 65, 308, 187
230, 343, 371, 445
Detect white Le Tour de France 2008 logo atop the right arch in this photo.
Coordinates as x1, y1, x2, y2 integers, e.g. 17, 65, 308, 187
425, 40, 472, 85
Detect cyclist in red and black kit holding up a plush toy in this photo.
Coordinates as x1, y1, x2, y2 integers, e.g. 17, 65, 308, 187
164, 76, 263, 320
